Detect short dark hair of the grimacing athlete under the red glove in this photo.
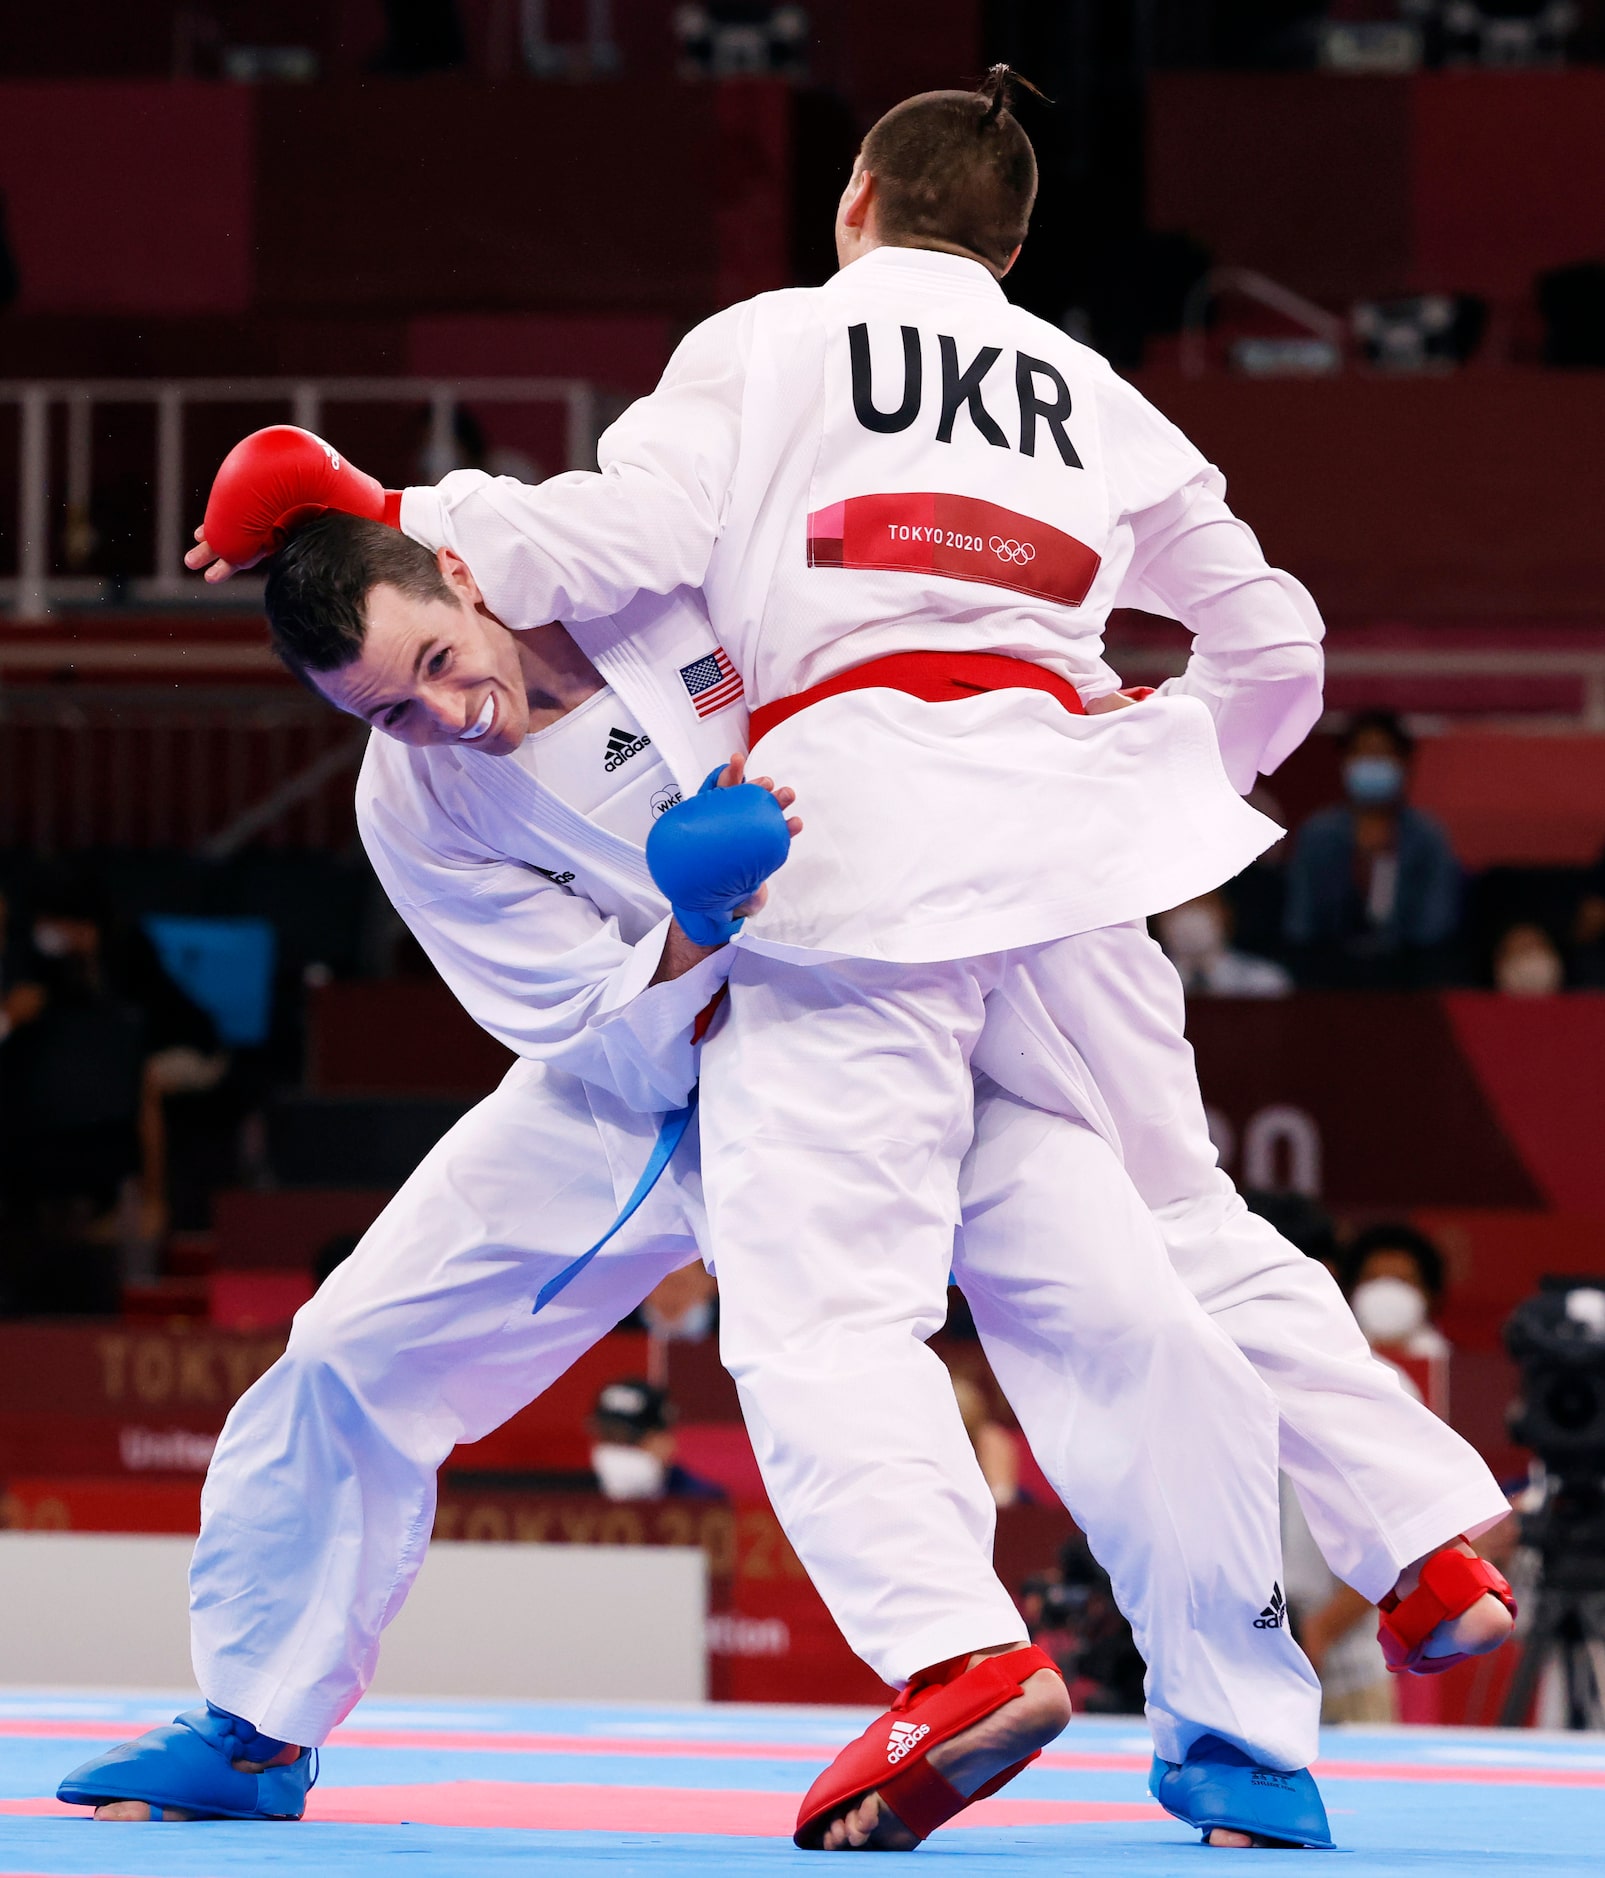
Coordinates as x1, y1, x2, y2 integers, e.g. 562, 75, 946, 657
263, 509, 451, 689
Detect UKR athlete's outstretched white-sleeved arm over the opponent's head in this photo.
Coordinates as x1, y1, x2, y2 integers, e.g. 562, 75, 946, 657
402, 306, 747, 625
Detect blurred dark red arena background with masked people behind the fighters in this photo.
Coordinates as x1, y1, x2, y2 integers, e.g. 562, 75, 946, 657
0, 0, 1605, 1718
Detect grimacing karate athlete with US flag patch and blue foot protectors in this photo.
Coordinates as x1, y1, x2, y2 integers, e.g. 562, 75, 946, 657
62, 499, 1314, 1847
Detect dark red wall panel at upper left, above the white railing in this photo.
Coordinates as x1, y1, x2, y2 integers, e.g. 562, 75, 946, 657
0, 79, 790, 319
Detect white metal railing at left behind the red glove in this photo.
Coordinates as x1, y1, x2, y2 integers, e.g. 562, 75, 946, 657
0, 377, 603, 622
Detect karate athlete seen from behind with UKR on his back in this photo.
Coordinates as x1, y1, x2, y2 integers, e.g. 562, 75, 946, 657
285, 69, 1509, 1847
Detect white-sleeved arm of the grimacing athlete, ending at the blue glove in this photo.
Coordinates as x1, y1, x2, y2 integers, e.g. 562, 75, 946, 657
357, 740, 730, 1114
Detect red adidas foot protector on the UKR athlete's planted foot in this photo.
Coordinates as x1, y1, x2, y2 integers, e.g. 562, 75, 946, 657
792, 1647, 1059, 1852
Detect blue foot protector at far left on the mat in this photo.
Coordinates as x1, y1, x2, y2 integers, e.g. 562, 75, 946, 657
56, 1701, 317, 1820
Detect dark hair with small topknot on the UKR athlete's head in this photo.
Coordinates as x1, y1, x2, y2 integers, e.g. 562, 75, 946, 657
860, 66, 1036, 267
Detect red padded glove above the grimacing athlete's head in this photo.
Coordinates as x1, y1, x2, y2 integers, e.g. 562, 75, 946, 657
203, 424, 402, 567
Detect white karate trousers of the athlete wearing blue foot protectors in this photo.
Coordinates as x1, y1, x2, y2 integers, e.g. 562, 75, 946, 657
191, 1063, 1314, 1763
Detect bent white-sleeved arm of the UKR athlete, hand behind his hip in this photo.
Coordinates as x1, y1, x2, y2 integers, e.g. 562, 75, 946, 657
1088, 374, 1323, 794
